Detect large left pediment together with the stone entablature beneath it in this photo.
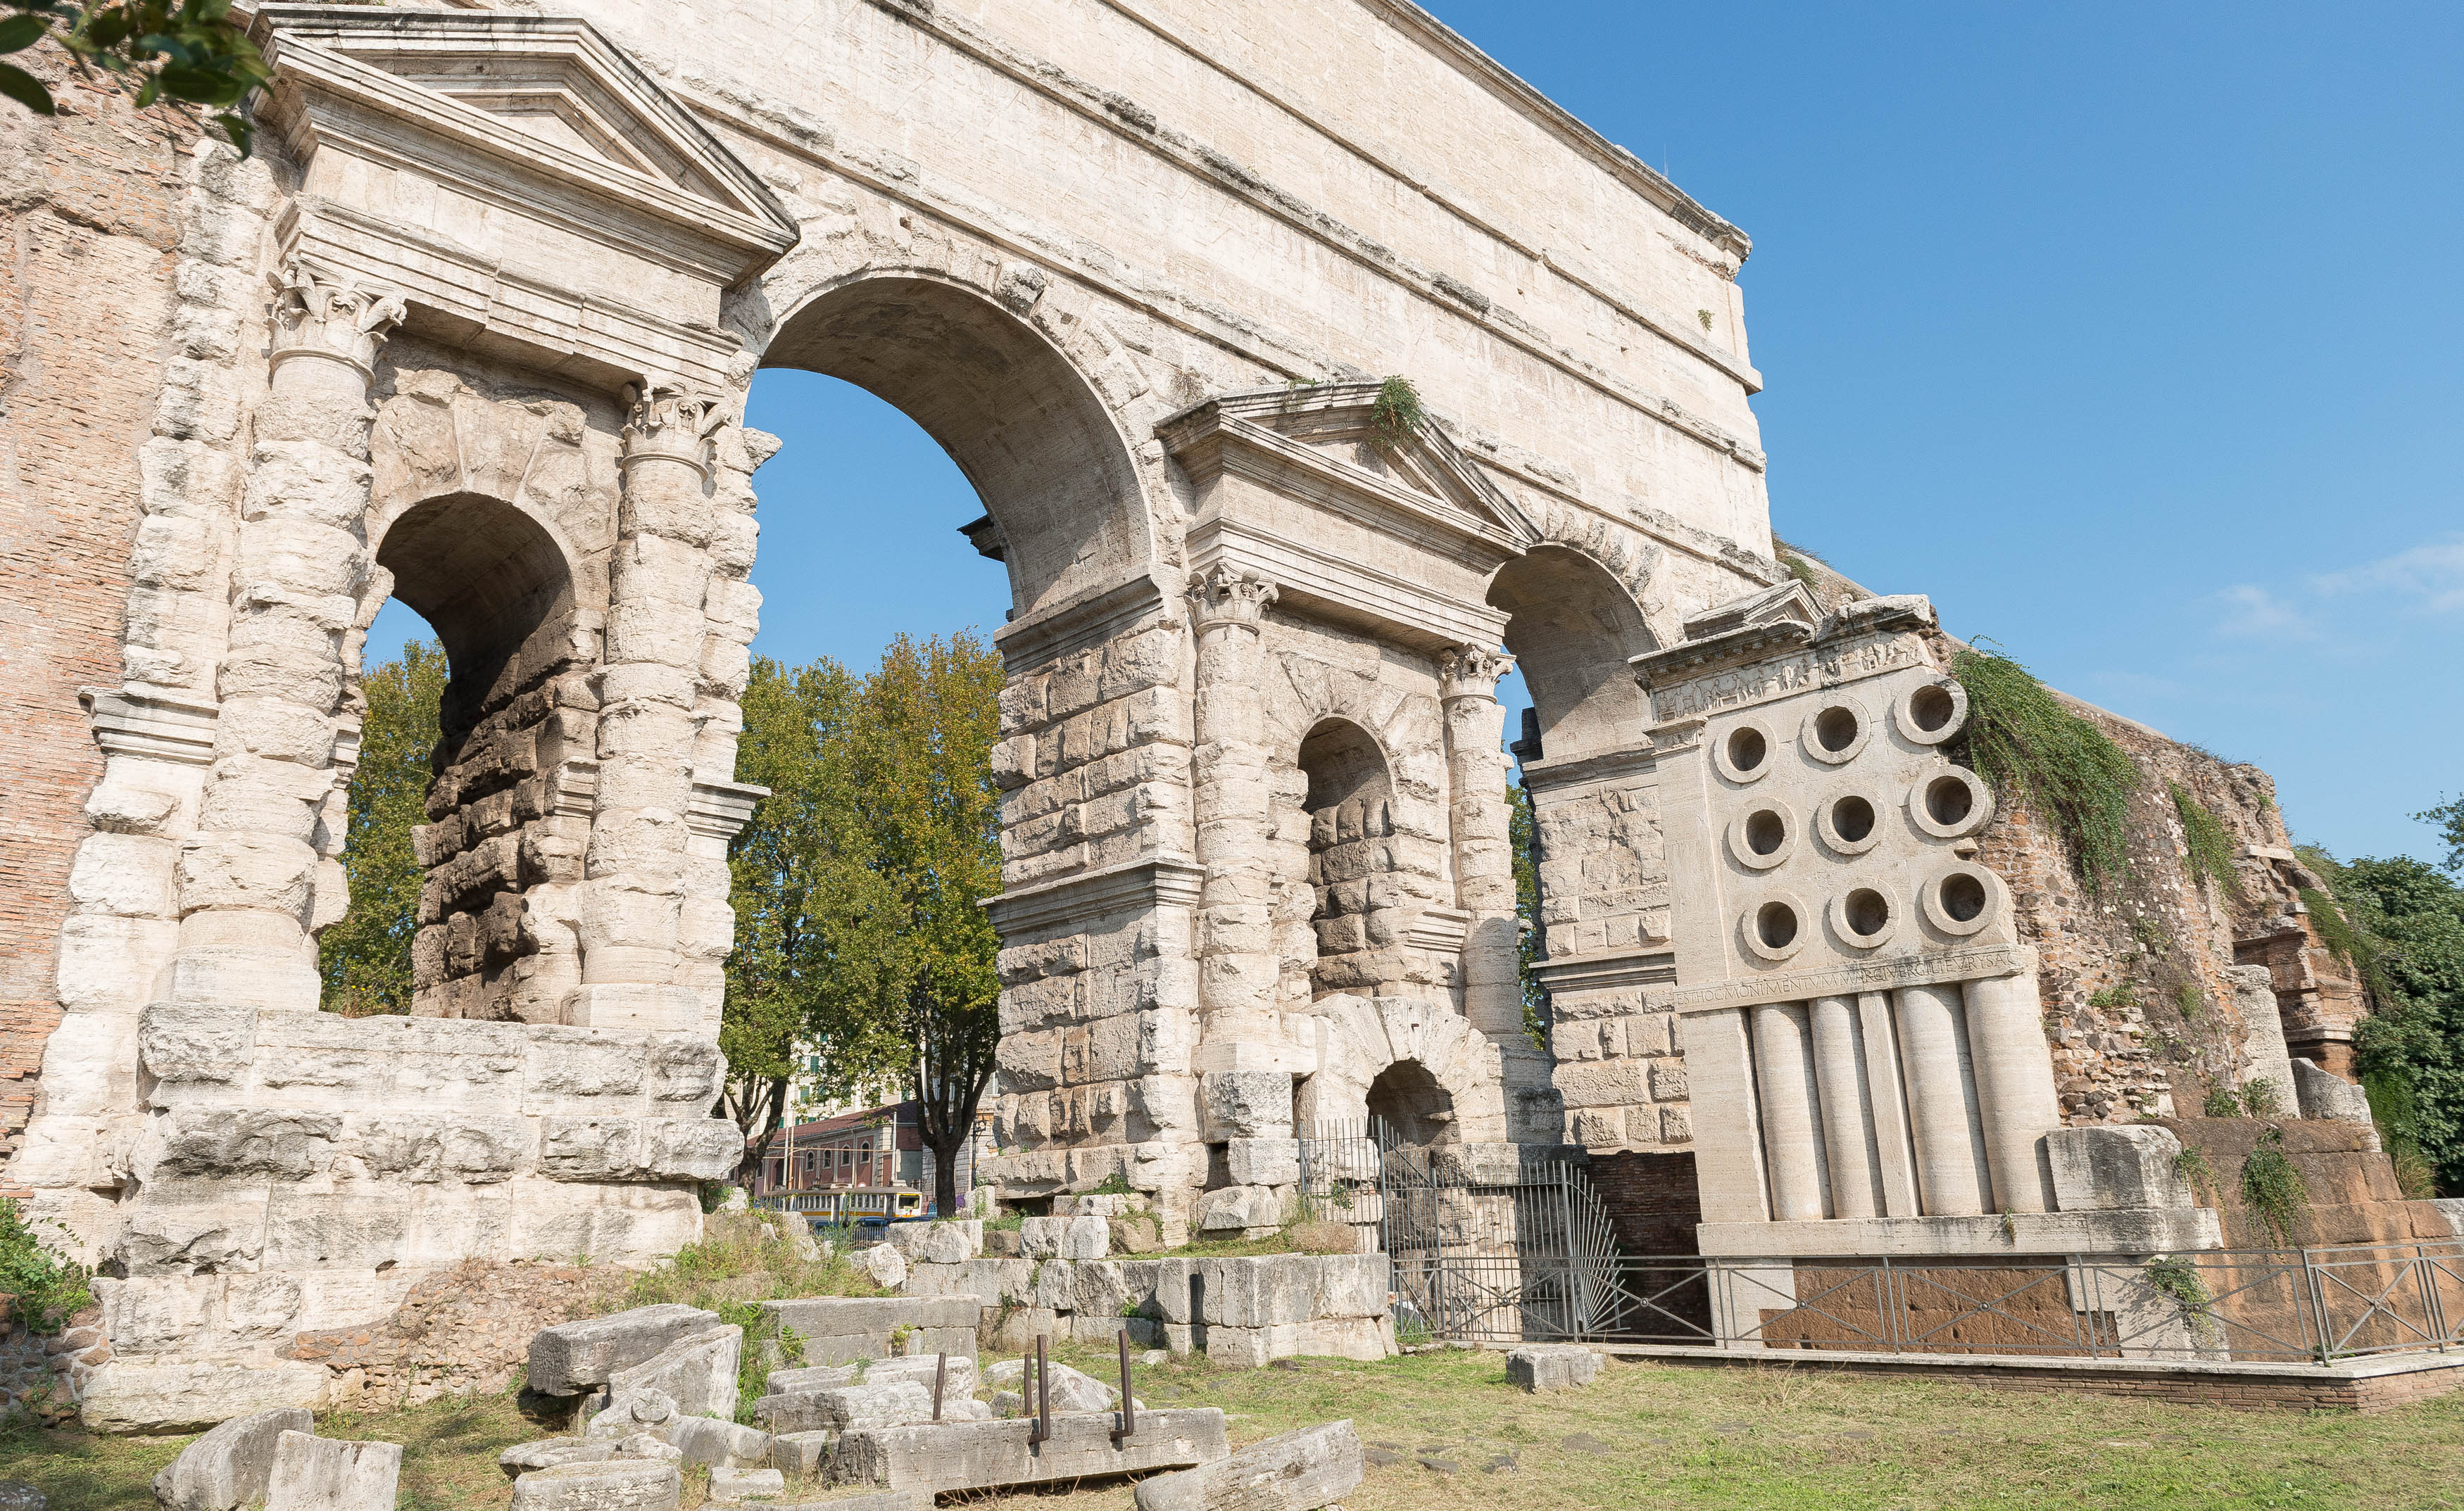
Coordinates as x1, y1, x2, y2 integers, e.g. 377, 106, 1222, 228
254, 5, 798, 387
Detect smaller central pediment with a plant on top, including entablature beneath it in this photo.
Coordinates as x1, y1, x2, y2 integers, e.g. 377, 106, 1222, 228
1156, 382, 1540, 646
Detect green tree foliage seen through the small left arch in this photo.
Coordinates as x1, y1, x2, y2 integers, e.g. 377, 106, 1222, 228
318, 641, 446, 1018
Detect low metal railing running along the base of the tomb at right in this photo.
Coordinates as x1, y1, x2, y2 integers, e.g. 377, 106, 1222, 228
1395, 1240, 2464, 1363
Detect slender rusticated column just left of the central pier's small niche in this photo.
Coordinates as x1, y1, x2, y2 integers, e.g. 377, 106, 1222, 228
1188, 564, 1289, 1050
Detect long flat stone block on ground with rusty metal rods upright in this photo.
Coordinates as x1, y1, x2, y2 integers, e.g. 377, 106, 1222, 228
831, 1408, 1230, 1493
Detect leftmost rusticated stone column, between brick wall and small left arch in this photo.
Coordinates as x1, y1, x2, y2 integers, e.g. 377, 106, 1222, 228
168, 261, 404, 1013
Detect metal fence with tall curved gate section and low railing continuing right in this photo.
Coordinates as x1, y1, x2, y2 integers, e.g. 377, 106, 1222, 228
1301, 1119, 2464, 1363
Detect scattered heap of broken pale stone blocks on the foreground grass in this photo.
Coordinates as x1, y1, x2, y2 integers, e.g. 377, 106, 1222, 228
485, 1282, 1360, 1511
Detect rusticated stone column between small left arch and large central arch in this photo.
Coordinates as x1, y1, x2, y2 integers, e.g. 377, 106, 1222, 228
565, 384, 729, 1030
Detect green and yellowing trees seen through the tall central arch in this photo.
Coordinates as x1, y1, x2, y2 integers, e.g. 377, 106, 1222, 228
722, 633, 1000, 1213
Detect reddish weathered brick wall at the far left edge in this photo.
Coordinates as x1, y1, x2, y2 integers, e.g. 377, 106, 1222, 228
0, 57, 195, 1153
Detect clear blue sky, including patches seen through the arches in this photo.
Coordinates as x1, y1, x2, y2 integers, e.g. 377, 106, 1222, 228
375, 0, 2464, 855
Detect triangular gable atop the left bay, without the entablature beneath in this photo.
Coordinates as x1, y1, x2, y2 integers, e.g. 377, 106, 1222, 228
256, 5, 798, 256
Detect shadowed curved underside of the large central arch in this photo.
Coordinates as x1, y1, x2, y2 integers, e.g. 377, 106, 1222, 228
764, 279, 1148, 614
